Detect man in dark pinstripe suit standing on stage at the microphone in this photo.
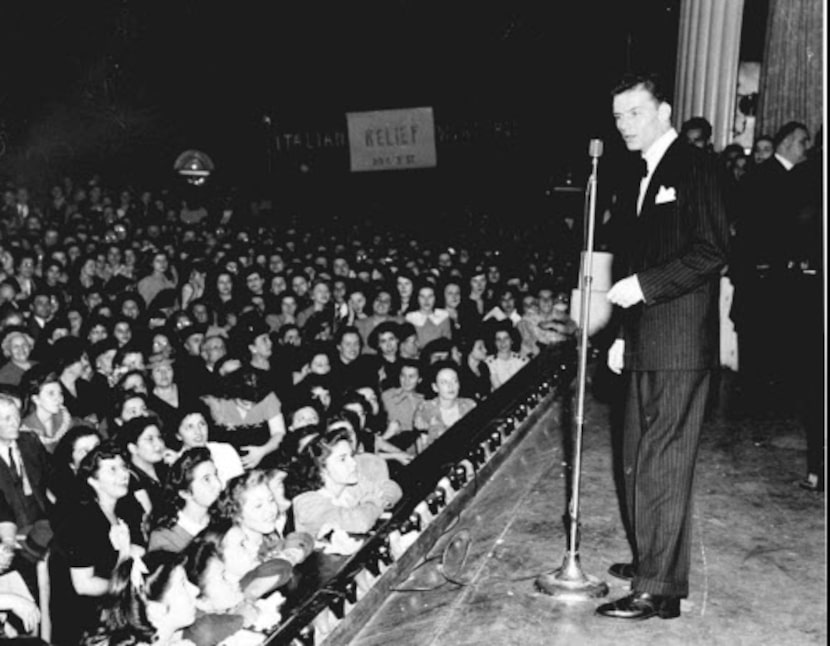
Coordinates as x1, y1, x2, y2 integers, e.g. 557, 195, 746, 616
597, 76, 728, 620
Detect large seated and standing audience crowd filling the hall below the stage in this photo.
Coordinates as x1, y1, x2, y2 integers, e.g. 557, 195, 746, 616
0, 177, 577, 645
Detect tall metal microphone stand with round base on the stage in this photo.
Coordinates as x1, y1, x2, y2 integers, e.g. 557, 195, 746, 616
536, 139, 608, 599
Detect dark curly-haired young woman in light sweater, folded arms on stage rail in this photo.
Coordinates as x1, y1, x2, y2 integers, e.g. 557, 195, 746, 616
289, 423, 401, 536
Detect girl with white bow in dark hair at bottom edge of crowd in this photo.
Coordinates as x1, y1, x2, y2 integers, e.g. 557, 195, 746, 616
82, 552, 199, 646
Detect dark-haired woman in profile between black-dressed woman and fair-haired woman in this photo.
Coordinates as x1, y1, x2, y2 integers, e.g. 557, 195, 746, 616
147, 447, 223, 552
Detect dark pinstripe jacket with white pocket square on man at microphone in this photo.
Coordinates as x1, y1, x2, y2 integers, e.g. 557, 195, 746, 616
617, 139, 728, 370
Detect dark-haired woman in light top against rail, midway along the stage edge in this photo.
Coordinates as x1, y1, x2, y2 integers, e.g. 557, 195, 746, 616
413, 361, 476, 452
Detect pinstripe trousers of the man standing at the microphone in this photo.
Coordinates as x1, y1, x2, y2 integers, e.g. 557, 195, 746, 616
623, 370, 711, 597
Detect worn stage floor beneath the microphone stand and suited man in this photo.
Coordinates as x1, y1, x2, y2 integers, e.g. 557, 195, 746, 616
352, 374, 827, 646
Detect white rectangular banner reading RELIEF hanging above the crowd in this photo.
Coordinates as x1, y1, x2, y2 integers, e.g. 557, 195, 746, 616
346, 108, 438, 172
